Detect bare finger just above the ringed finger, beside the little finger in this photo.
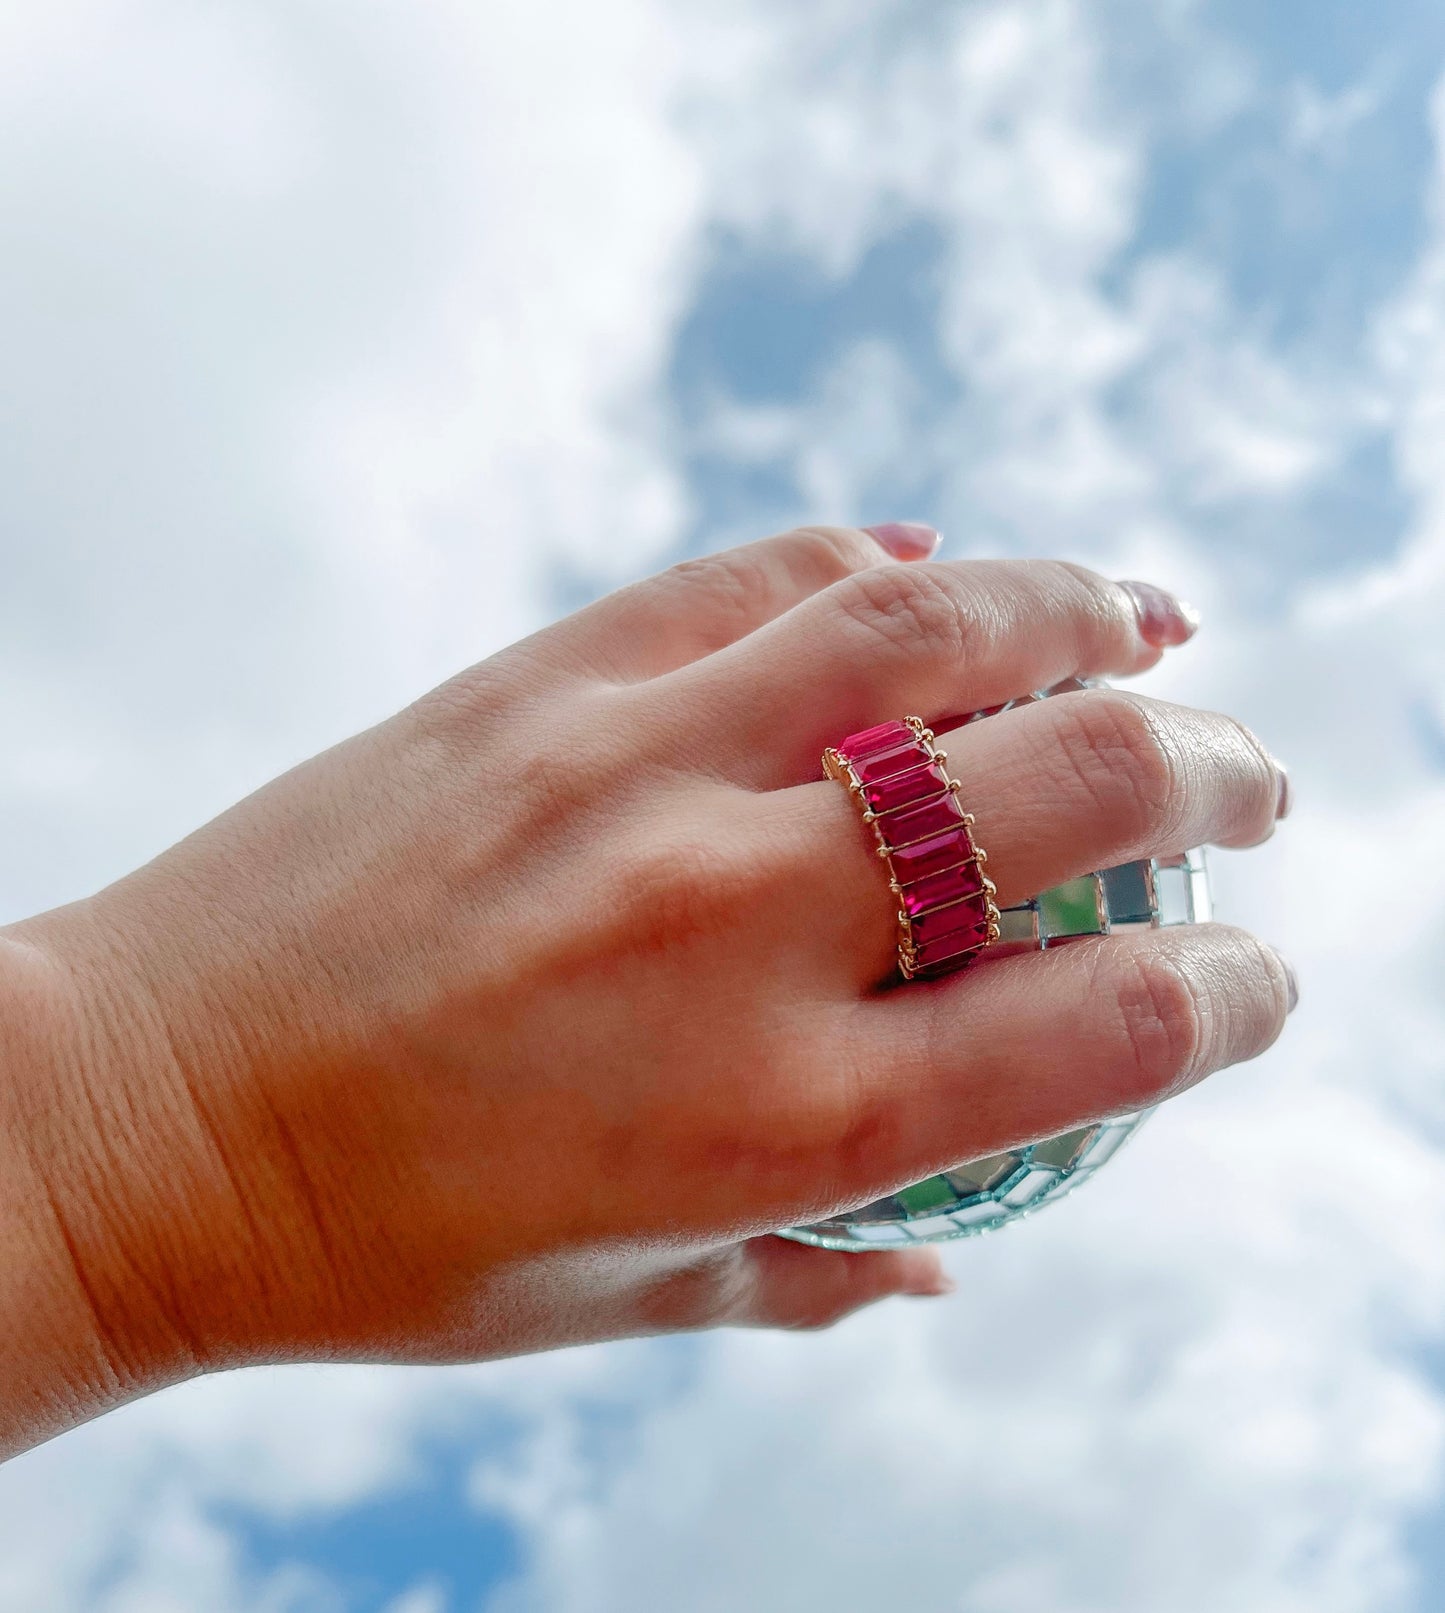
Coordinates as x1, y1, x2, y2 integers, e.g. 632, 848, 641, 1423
668, 560, 1184, 789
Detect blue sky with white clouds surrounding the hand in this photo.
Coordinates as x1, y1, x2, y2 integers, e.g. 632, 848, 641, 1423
0, 0, 1445, 1613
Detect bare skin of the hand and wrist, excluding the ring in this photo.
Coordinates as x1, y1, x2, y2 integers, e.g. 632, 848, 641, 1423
0, 529, 1292, 1453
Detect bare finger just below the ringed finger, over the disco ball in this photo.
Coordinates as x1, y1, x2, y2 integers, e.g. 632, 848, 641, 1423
832, 924, 1295, 1203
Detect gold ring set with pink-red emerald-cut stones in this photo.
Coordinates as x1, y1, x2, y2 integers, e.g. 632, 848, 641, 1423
822, 716, 998, 981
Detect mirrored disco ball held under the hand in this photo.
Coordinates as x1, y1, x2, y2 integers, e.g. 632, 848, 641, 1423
782, 679, 1211, 1250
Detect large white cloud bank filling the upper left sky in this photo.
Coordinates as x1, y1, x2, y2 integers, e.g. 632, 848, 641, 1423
0, 0, 698, 915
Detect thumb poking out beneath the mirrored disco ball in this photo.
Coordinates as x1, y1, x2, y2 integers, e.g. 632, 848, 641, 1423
673, 1236, 953, 1327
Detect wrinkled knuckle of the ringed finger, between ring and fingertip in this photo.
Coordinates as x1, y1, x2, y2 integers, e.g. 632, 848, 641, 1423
1048, 689, 1181, 842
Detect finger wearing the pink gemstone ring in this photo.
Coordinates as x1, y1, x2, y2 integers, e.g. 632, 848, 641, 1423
783, 689, 1281, 986
